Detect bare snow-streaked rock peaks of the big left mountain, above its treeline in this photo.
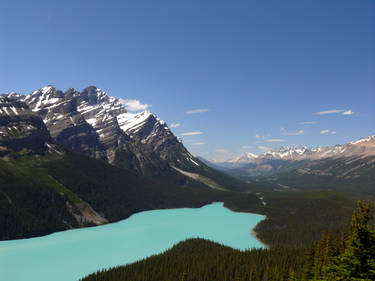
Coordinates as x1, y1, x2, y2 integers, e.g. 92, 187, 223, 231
24, 86, 194, 172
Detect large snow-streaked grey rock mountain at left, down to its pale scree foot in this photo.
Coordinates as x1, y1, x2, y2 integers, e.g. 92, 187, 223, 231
0, 85, 251, 190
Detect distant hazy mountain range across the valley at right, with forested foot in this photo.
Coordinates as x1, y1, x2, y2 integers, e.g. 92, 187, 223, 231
206, 135, 375, 192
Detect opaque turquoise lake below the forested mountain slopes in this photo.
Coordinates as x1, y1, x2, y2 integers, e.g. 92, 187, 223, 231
0, 203, 264, 281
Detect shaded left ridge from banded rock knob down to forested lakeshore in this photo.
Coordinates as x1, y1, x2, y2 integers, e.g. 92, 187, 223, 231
0, 95, 231, 239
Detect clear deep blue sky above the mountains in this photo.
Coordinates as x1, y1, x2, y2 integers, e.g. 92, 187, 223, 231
0, 0, 375, 159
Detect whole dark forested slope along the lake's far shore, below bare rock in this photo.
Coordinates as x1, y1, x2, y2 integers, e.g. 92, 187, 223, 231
0, 152, 261, 240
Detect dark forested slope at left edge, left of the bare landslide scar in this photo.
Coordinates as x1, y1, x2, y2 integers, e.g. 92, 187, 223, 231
0, 153, 78, 240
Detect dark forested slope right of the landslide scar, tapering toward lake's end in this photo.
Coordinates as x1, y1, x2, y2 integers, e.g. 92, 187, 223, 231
45, 152, 229, 221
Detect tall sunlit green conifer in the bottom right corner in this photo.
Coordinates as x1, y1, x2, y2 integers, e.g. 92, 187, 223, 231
326, 202, 375, 281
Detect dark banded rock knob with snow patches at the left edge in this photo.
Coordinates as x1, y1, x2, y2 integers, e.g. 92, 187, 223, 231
0, 94, 53, 156
